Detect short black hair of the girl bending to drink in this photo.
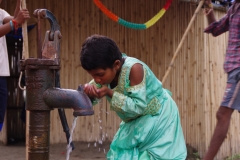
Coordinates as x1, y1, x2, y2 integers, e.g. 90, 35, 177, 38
80, 35, 122, 71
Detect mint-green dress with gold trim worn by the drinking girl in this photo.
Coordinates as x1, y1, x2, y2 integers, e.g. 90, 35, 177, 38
91, 54, 187, 160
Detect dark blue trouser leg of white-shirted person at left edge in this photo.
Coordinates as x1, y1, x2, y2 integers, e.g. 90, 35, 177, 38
0, 77, 8, 131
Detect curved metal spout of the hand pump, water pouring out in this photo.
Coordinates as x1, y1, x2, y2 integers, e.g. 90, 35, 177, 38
43, 87, 94, 117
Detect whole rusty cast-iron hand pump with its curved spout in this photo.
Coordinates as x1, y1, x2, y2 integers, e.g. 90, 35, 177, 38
20, 9, 94, 160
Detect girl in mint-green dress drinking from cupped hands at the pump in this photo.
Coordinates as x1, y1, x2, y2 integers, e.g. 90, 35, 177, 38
80, 35, 187, 160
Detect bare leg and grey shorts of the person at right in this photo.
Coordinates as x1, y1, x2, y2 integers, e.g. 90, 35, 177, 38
203, 68, 240, 160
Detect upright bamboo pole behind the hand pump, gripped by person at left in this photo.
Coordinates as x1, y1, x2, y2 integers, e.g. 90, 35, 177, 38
21, 0, 29, 159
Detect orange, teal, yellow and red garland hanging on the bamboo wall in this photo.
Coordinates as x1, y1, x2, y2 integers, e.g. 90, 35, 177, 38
94, 0, 172, 29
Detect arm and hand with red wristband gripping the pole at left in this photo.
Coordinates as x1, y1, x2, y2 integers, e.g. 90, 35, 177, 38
0, 0, 30, 37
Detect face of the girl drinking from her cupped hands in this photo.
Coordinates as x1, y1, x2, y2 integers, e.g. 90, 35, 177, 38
87, 60, 121, 85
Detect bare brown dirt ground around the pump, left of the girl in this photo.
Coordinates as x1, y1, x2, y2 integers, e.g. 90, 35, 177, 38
0, 142, 109, 160
